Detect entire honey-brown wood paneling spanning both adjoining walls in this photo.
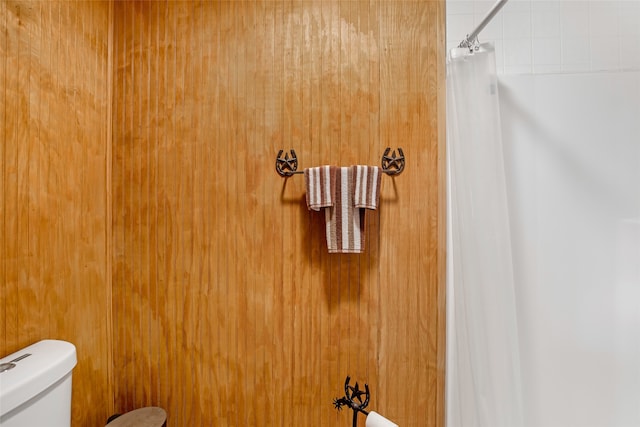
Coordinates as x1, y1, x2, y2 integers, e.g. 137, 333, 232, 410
0, 0, 445, 426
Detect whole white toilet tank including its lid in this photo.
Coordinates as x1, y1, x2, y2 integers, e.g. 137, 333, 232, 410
0, 340, 77, 427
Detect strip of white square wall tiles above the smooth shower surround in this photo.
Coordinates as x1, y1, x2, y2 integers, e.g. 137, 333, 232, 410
447, 0, 640, 74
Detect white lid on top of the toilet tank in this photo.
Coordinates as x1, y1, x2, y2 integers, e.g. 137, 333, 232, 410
0, 340, 77, 416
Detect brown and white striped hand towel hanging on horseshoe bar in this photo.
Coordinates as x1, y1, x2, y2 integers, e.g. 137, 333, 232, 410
305, 166, 380, 253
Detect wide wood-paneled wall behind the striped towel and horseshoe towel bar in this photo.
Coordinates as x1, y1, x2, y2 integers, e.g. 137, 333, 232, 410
113, 0, 445, 427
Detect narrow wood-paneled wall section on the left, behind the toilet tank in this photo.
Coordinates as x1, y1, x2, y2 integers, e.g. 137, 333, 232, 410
0, 0, 113, 426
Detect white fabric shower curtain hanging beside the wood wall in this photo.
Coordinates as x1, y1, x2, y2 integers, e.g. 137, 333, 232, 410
447, 44, 524, 427
